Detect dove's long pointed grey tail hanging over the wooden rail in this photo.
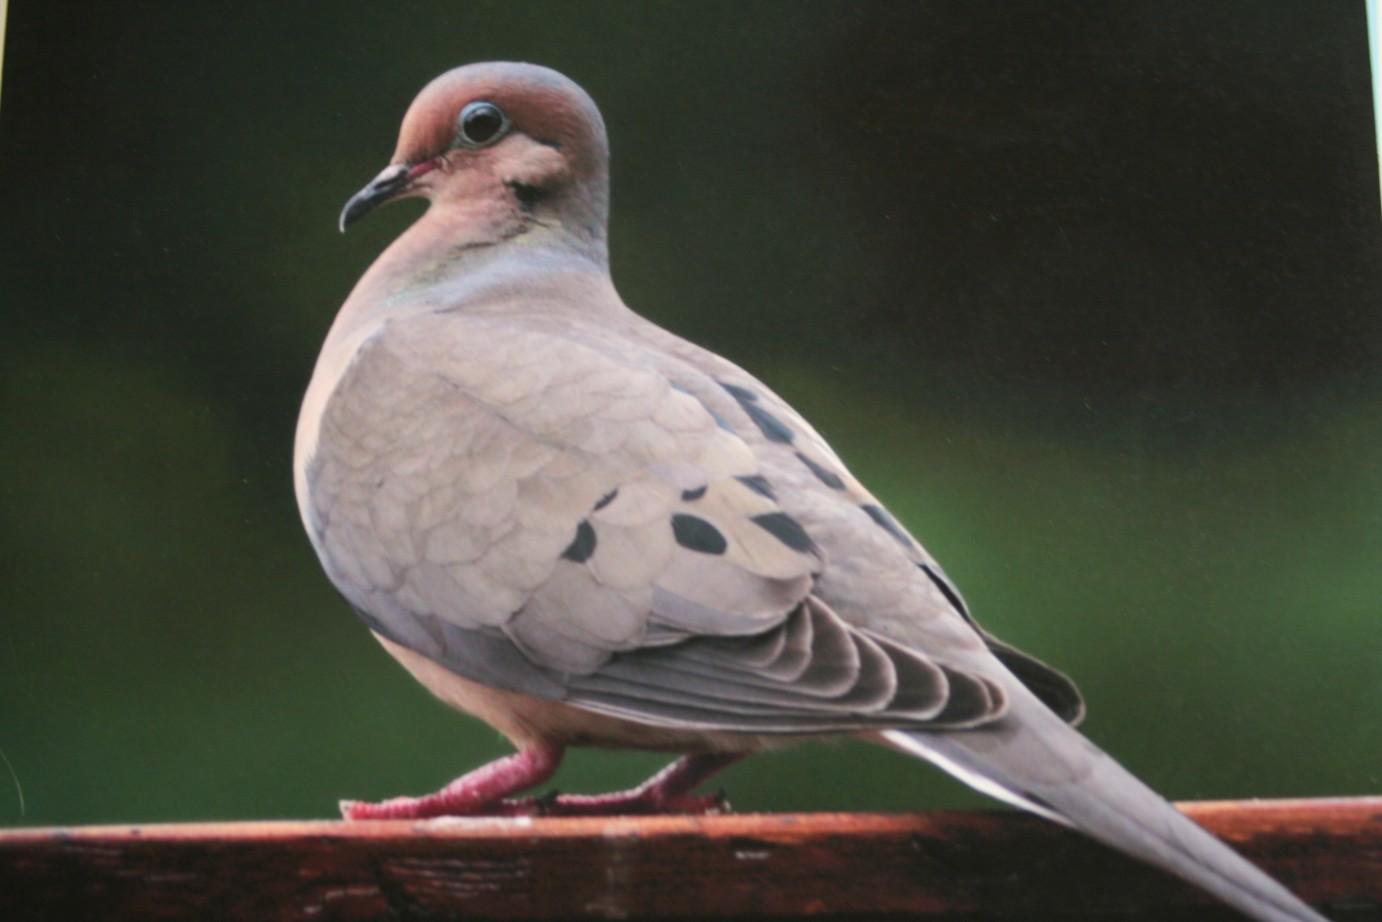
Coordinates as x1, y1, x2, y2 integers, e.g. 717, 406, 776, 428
883, 688, 1324, 922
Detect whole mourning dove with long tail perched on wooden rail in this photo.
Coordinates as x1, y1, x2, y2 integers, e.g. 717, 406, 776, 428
294, 64, 1321, 921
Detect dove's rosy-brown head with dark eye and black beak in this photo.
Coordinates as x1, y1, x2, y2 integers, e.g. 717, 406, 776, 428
340, 62, 609, 249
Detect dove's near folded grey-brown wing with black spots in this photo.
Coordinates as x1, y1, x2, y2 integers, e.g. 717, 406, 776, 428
307, 314, 1005, 733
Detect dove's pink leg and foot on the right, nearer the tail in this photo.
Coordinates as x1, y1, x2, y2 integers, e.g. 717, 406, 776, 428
509, 752, 744, 817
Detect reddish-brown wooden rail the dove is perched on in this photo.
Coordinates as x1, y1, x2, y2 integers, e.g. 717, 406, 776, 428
0, 798, 1382, 922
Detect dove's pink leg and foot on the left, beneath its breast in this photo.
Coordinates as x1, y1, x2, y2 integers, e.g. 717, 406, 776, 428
340, 745, 562, 820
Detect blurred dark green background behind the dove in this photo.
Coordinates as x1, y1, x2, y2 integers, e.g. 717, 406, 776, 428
0, 0, 1382, 824
